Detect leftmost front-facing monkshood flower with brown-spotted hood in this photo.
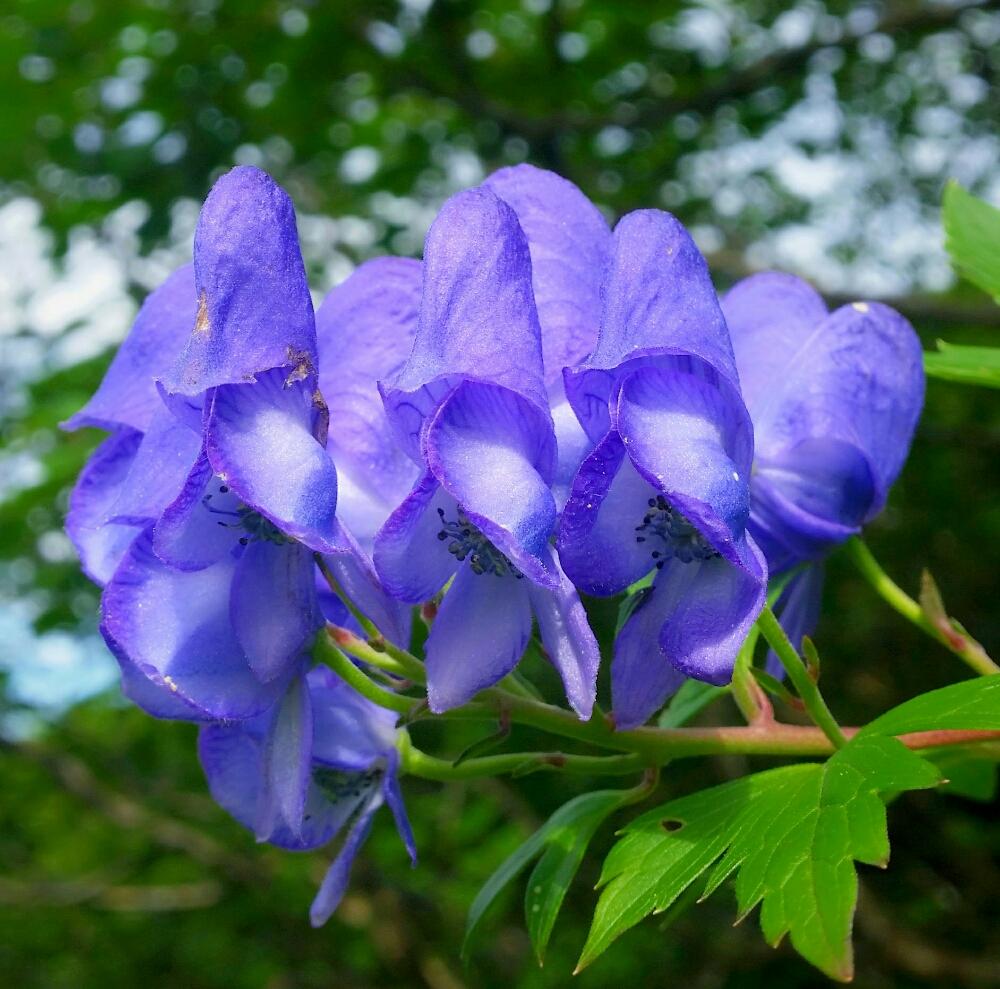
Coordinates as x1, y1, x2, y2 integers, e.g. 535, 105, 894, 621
71, 168, 407, 720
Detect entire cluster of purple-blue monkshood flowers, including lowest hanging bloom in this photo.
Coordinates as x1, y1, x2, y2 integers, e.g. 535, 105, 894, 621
60, 166, 923, 923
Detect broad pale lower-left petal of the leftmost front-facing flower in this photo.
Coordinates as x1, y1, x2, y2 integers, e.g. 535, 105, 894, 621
101, 529, 284, 720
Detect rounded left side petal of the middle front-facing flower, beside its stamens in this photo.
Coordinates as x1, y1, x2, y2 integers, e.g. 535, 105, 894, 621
374, 473, 458, 604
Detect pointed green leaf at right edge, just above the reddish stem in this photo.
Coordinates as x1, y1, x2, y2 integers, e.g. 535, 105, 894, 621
858, 675, 1000, 737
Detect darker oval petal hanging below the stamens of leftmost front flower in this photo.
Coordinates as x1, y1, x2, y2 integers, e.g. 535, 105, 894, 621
229, 539, 320, 683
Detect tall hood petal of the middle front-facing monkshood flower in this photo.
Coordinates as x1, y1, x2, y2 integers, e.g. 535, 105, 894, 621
382, 189, 549, 462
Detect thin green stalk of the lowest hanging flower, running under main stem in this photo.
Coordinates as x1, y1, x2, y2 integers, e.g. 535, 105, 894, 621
400, 735, 646, 782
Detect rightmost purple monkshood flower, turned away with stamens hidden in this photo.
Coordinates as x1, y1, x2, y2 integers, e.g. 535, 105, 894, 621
722, 272, 924, 656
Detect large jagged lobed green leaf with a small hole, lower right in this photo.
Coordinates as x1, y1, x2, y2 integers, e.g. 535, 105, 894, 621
579, 738, 940, 980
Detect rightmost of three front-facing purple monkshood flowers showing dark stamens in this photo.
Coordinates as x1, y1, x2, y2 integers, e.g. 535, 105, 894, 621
558, 210, 767, 728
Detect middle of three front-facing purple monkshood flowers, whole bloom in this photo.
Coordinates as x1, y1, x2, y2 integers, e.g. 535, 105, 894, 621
375, 189, 598, 718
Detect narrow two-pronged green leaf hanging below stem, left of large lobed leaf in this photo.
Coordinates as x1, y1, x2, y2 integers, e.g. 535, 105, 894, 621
462, 790, 629, 961
